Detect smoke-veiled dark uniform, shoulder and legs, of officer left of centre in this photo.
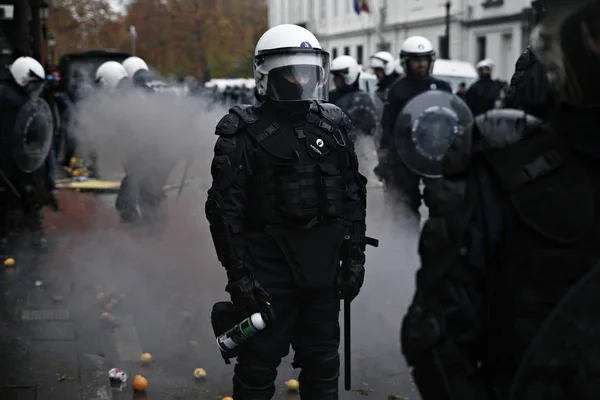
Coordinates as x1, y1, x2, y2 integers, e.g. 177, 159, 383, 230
116, 70, 177, 229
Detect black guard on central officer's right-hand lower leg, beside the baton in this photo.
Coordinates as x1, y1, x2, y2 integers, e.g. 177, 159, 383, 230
295, 353, 340, 400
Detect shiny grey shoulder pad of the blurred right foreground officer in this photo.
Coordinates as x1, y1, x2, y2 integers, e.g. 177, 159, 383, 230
475, 109, 543, 148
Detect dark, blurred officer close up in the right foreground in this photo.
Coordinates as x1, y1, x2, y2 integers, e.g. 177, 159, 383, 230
402, 0, 600, 400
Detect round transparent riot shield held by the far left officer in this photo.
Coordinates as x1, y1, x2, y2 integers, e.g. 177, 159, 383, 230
10, 98, 53, 173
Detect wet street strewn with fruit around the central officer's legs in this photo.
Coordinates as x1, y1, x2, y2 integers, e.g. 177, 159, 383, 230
0, 175, 419, 400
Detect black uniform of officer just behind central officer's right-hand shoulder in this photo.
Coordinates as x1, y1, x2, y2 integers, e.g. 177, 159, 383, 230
329, 83, 377, 135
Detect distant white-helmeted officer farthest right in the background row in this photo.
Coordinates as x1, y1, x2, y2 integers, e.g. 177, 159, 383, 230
465, 58, 507, 116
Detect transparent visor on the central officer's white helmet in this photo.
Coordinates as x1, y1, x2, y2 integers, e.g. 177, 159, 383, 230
254, 49, 329, 102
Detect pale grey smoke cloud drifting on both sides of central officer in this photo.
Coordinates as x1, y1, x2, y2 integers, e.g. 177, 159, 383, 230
58, 86, 418, 398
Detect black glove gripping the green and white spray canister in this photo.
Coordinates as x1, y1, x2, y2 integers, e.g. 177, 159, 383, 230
225, 267, 271, 315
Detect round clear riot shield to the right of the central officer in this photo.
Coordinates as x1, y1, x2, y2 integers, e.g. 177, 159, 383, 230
394, 90, 473, 178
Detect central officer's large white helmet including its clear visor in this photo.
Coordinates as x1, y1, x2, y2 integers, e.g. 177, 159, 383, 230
254, 24, 329, 102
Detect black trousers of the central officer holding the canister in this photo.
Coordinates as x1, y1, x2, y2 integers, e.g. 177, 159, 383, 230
233, 235, 340, 400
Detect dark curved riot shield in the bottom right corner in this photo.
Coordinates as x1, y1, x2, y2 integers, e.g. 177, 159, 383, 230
508, 264, 600, 400
